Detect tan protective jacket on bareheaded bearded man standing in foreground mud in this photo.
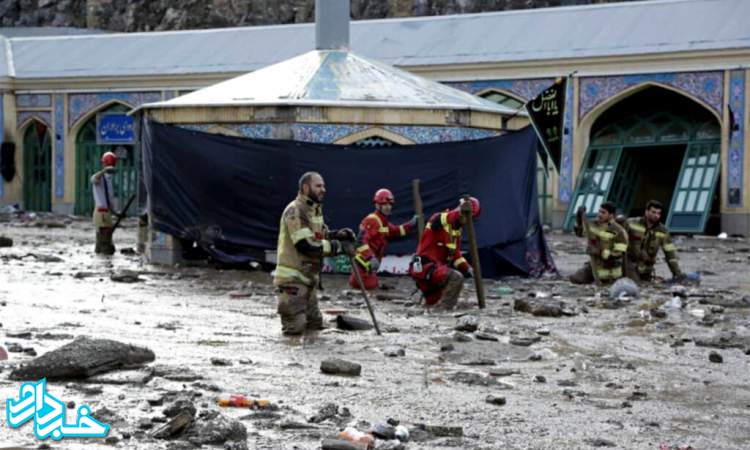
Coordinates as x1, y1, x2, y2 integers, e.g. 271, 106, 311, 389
273, 193, 333, 287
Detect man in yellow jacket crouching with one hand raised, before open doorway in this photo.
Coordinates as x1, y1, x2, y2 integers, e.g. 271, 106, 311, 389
569, 202, 628, 284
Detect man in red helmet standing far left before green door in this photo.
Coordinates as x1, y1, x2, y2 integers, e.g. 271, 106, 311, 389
91, 152, 117, 255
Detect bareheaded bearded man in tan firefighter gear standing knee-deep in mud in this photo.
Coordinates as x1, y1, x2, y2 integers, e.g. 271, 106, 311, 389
273, 172, 355, 335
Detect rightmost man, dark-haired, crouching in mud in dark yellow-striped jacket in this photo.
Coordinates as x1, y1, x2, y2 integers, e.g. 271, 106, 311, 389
621, 200, 685, 283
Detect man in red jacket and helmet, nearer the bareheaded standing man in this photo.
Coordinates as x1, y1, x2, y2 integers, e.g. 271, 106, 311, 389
349, 189, 418, 290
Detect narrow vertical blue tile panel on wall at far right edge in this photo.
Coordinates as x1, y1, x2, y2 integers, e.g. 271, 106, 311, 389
727, 70, 747, 207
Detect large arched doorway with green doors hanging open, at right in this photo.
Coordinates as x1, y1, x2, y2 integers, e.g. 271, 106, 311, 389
565, 87, 721, 233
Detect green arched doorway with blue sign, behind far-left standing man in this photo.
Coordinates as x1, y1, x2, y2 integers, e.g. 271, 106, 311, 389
74, 104, 138, 215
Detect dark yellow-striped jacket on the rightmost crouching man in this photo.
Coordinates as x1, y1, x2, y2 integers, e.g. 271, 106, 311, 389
623, 217, 682, 277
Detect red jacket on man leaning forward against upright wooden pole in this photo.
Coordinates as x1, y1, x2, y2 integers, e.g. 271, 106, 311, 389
417, 210, 469, 272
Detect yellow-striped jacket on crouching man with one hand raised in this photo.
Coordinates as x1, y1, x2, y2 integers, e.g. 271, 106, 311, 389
574, 218, 628, 283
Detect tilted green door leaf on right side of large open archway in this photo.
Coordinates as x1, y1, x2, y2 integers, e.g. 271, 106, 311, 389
667, 141, 721, 233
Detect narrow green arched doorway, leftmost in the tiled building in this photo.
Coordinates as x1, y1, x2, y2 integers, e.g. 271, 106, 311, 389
23, 120, 52, 211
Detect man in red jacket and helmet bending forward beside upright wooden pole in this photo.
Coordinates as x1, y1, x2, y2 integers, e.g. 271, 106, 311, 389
409, 197, 481, 309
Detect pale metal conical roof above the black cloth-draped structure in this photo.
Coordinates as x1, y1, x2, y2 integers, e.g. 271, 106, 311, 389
142, 50, 516, 115
